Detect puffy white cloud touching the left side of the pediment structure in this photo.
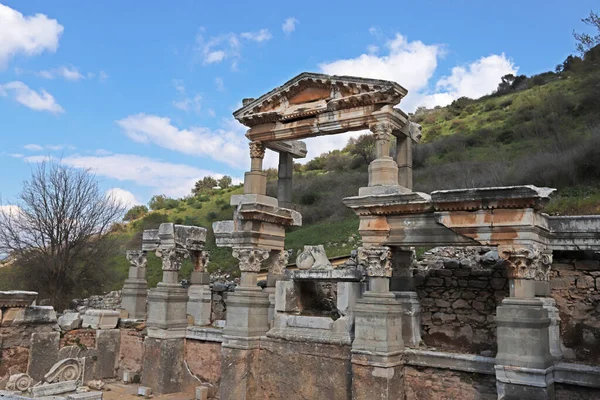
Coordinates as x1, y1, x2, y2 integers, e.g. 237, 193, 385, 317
116, 113, 250, 168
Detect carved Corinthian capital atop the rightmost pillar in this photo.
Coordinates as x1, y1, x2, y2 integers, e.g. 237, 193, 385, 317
498, 245, 552, 281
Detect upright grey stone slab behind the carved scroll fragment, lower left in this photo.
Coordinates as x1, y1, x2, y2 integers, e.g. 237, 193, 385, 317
27, 332, 60, 382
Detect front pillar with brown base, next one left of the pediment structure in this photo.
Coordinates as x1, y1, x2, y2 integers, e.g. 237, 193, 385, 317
142, 247, 189, 394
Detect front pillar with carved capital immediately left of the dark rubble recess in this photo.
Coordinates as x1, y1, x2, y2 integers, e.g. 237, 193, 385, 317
352, 246, 404, 400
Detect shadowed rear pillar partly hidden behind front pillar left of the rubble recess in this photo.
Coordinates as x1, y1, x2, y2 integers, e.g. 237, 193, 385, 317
390, 248, 421, 347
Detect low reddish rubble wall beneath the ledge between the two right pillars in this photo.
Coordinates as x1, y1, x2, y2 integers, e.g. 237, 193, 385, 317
404, 366, 498, 400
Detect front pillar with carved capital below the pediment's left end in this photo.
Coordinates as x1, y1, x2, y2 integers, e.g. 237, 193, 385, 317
219, 247, 270, 400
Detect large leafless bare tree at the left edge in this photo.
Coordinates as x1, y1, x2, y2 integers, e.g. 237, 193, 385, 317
0, 162, 124, 309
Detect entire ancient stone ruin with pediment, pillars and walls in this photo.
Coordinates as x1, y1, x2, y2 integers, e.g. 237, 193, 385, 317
0, 73, 600, 400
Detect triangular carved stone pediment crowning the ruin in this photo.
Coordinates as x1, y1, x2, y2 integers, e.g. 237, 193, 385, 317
233, 72, 408, 127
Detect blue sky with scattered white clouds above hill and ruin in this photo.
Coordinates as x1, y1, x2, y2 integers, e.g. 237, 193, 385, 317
0, 0, 597, 209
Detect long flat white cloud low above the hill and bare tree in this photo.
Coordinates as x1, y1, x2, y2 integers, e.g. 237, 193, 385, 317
62, 154, 223, 197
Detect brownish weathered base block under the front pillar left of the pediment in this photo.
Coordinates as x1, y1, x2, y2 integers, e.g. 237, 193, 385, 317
142, 337, 198, 394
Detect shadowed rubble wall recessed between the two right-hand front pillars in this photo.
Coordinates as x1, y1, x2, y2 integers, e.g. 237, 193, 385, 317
414, 247, 508, 356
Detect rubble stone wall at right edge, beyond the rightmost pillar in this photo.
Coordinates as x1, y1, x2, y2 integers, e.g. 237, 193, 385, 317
550, 252, 600, 365
